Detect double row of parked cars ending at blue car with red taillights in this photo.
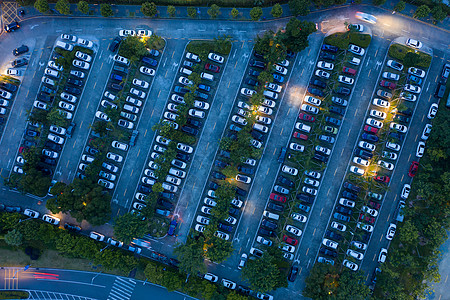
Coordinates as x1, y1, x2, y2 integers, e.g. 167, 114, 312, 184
132, 52, 225, 227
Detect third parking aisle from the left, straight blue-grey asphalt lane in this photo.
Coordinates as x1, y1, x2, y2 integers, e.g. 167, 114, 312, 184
111, 39, 187, 218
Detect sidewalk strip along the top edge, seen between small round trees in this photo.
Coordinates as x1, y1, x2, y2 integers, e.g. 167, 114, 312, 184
14, 0, 450, 30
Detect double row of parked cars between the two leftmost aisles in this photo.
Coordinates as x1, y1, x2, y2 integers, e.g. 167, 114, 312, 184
13, 34, 93, 176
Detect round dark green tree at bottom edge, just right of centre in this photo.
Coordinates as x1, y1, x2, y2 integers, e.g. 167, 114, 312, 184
241, 252, 287, 293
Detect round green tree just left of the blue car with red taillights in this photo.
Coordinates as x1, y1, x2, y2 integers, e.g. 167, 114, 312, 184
114, 213, 147, 244
